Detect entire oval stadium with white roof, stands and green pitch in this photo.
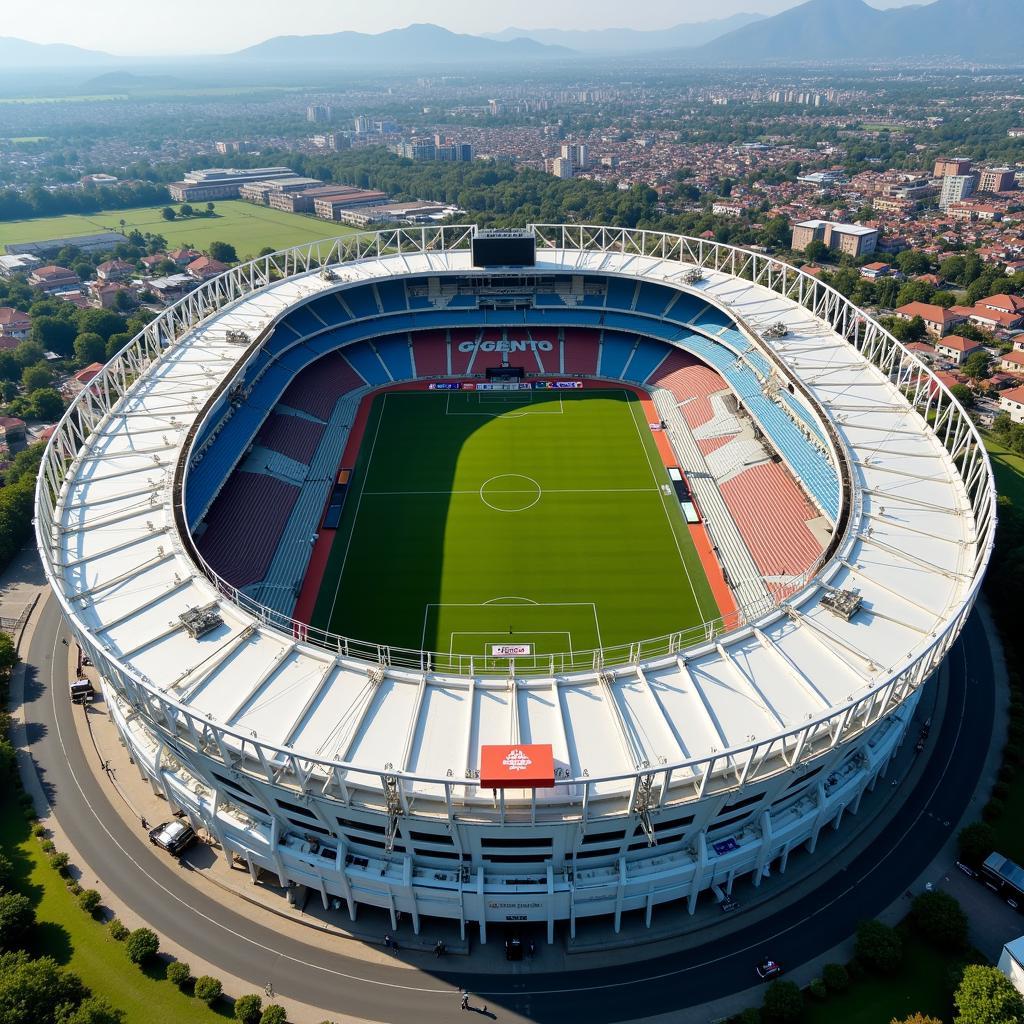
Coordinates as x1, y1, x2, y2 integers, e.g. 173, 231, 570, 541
36, 225, 995, 941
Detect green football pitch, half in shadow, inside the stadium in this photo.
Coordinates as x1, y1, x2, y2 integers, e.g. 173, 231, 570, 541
312, 390, 718, 671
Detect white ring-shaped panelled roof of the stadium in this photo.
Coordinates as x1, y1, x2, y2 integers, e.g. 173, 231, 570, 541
37, 237, 978, 799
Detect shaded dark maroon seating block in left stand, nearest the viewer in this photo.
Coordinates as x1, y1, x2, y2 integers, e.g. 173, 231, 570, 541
198, 472, 299, 587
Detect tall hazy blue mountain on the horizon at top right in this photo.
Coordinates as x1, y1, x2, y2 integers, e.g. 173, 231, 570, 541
691, 0, 1024, 63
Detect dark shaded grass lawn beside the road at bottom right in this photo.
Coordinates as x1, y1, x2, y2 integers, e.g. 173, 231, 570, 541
802, 929, 953, 1024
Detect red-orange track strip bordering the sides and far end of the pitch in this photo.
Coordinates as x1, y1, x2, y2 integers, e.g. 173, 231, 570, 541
293, 380, 736, 624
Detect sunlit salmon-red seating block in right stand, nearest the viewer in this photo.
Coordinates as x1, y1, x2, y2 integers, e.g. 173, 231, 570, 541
720, 462, 821, 588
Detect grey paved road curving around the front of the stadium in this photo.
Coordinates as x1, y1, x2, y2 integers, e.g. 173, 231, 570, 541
26, 600, 994, 1024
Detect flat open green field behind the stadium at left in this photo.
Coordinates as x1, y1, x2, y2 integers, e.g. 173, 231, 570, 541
0, 200, 354, 259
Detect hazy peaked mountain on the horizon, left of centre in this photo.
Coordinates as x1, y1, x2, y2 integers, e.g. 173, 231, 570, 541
232, 25, 569, 67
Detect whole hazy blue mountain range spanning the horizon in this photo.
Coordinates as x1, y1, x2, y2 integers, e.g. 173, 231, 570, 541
0, 0, 1024, 70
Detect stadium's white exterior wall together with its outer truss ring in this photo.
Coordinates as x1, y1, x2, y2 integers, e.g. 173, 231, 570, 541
37, 225, 995, 938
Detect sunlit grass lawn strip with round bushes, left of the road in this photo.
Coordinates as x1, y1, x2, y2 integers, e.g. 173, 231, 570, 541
0, 801, 226, 1024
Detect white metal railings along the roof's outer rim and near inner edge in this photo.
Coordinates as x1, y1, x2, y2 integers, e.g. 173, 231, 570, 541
36, 224, 996, 798
